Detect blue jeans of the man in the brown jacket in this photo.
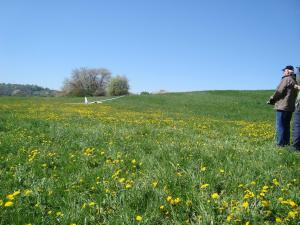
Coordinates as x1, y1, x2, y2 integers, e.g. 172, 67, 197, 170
276, 110, 293, 146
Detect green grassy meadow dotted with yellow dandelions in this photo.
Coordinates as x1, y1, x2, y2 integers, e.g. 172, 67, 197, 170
0, 91, 300, 225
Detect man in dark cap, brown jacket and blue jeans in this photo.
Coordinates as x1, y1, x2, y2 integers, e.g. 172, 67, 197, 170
267, 65, 298, 147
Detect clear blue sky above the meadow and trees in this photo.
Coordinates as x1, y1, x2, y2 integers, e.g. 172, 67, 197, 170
0, 0, 300, 93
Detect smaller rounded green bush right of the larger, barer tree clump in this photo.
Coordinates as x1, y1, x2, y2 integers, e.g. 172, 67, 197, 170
107, 76, 129, 96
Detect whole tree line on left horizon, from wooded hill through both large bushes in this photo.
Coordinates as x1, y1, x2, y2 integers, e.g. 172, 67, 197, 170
0, 67, 129, 97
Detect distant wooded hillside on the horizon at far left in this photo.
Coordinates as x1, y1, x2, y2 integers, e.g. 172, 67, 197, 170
0, 83, 57, 97
